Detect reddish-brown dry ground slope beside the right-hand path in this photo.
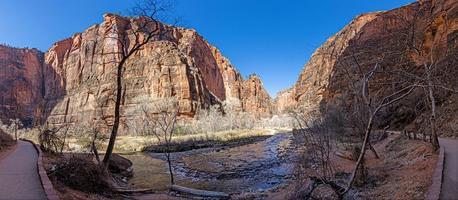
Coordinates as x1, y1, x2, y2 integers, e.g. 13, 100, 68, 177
361, 136, 437, 200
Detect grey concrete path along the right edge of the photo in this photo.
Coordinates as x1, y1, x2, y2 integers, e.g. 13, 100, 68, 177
439, 138, 458, 200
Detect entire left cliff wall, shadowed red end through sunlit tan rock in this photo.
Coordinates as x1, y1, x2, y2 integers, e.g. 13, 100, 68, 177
0, 14, 271, 128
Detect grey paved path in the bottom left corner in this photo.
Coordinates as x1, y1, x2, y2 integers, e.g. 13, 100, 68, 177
0, 141, 46, 200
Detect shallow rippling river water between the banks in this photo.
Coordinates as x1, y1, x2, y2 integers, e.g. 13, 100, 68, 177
124, 133, 293, 194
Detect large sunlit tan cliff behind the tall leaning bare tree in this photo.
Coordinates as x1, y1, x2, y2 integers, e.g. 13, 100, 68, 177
45, 14, 276, 130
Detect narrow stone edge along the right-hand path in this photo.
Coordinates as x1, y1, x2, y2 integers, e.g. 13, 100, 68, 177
425, 147, 445, 200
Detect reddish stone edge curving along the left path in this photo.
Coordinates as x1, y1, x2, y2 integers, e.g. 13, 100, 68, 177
21, 138, 60, 200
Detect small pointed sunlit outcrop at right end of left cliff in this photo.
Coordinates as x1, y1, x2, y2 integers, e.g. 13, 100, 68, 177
241, 74, 273, 117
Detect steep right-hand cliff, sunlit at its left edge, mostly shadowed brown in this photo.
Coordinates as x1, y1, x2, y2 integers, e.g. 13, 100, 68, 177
292, 0, 458, 129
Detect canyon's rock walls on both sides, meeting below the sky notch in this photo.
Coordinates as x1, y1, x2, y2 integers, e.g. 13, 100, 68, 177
0, 0, 458, 136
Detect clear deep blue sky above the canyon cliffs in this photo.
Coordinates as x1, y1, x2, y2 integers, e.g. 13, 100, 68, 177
0, 0, 414, 97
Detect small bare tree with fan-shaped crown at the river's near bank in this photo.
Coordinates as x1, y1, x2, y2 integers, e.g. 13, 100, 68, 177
142, 98, 179, 185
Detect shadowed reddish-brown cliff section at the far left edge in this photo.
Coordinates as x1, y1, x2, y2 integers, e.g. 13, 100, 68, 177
0, 45, 44, 125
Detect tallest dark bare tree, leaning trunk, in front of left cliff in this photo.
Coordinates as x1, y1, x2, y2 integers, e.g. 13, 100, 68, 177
102, 0, 177, 167
